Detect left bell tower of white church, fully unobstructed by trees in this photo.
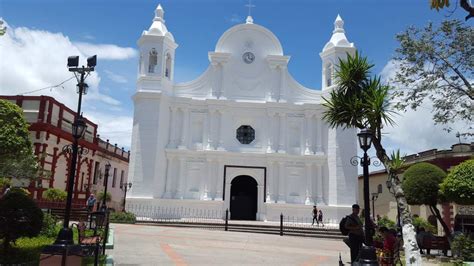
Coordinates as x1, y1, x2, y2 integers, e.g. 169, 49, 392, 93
137, 2, 178, 92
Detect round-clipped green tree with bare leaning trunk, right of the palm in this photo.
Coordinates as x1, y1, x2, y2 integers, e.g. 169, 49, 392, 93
402, 162, 451, 236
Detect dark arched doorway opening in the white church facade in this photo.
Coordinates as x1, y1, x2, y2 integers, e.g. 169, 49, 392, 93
230, 175, 257, 220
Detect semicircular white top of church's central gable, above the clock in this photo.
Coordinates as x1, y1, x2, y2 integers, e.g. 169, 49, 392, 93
215, 16, 283, 55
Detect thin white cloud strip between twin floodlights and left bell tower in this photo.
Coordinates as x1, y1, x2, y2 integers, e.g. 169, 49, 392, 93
74, 42, 138, 60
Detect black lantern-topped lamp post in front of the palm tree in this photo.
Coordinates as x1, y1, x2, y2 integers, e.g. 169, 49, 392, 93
357, 129, 377, 265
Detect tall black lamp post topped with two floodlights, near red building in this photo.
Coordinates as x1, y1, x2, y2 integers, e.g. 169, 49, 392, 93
43, 55, 97, 265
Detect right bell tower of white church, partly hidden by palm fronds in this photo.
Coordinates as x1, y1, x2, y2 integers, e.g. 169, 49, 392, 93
319, 15, 356, 91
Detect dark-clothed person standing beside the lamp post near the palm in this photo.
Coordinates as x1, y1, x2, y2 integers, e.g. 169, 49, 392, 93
345, 204, 364, 263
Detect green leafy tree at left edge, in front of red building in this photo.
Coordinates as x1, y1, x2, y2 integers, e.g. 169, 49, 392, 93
0, 100, 42, 179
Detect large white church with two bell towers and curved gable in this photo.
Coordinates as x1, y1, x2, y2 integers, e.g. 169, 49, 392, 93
127, 5, 357, 221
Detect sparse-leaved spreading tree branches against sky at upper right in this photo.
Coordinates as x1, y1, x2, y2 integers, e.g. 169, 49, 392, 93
393, 20, 474, 134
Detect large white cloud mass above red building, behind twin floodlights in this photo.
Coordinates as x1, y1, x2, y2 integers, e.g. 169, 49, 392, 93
0, 21, 134, 147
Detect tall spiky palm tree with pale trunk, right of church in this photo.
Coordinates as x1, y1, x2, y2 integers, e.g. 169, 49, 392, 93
323, 52, 421, 265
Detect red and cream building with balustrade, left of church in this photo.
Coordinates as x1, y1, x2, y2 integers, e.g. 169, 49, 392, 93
0, 96, 130, 209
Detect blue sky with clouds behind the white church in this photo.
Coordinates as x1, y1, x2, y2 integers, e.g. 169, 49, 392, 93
0, 0, 472, 153
